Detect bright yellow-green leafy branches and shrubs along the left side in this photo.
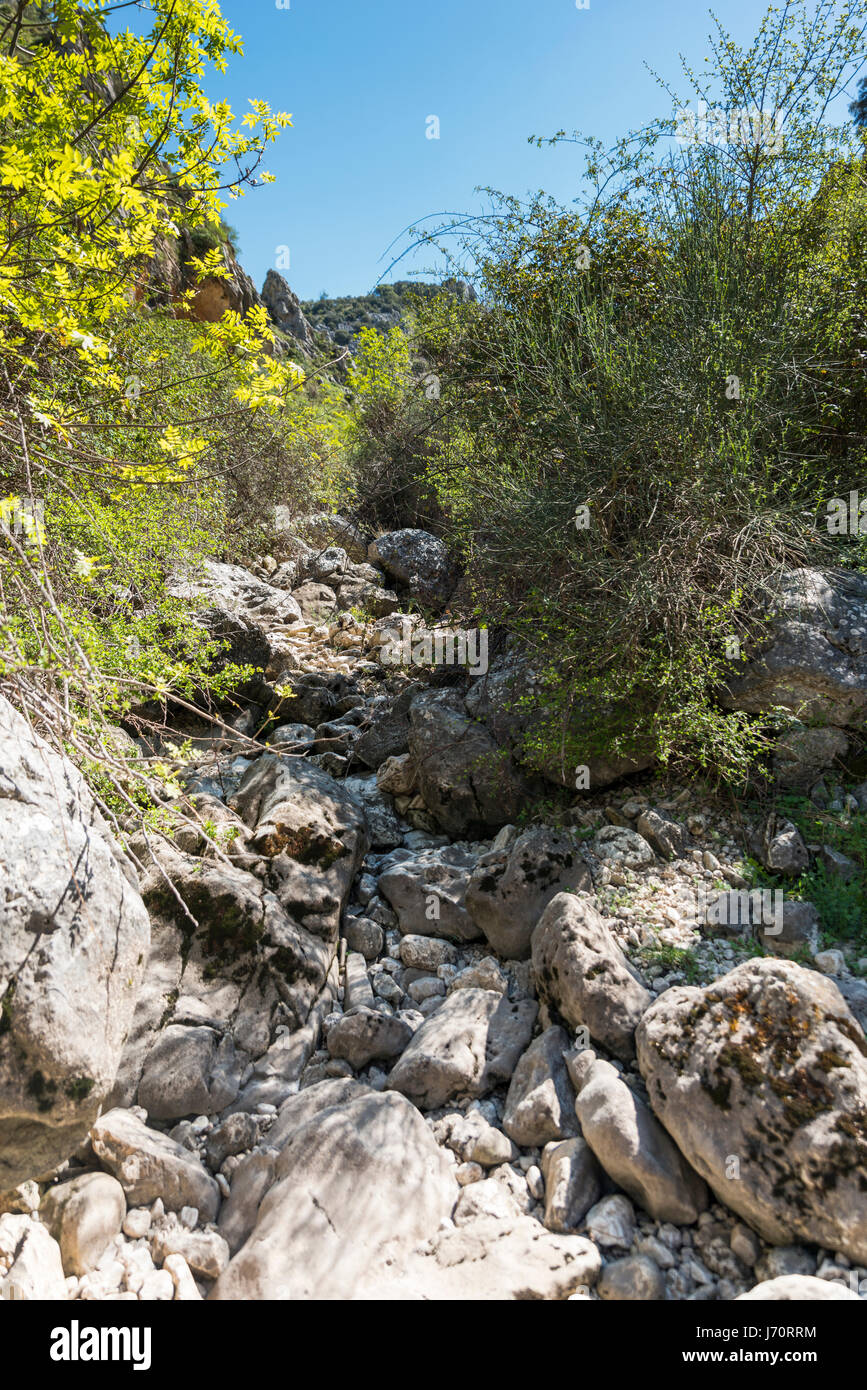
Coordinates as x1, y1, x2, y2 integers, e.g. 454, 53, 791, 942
0, 0, 352, 811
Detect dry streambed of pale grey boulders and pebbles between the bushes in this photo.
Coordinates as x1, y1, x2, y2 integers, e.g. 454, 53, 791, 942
0, 525, 867, 1301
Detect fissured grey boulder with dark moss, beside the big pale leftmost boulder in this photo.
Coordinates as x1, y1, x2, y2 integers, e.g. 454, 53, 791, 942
111, 847, 327, 1119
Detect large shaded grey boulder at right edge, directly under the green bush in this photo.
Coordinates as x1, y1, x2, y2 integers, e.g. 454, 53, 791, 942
723, 569, 867, 728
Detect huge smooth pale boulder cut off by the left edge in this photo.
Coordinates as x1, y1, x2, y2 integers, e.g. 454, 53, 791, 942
0, 698, 150, 1191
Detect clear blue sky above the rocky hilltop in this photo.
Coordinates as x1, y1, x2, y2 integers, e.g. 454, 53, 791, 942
206, 0, 839, 299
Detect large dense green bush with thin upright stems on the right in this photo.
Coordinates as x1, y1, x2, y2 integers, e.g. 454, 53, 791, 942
354, 3, 867, 783
